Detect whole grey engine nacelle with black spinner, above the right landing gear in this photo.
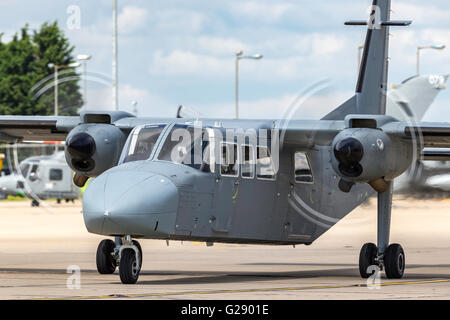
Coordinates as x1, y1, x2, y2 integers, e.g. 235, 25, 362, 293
332, 128, 414, 192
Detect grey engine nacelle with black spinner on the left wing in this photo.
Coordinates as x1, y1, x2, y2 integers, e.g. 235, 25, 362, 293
65, 124, 126, 179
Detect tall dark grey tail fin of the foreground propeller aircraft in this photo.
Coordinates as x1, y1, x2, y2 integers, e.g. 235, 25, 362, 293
323, 0, 411, 120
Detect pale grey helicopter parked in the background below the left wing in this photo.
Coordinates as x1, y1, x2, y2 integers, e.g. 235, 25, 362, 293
0, 152, 81, 206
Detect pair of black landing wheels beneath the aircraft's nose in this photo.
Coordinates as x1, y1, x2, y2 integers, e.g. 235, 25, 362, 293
96, 236, 142, 284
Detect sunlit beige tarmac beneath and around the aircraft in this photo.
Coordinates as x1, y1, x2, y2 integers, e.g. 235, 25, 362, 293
0, 197, 450, 300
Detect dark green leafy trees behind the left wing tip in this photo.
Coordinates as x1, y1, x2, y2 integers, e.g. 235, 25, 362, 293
0, 22, 83, 116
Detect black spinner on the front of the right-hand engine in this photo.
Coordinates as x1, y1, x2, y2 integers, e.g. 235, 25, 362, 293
333, 138, 364, 178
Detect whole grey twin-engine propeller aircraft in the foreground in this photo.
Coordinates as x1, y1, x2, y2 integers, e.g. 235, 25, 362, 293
0, 0, 450, 283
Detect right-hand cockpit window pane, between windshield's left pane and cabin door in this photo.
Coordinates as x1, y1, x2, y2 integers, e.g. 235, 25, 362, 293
158, 124, 211, 172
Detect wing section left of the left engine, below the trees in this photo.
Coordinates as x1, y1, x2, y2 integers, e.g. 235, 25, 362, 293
0, 116, 80, 142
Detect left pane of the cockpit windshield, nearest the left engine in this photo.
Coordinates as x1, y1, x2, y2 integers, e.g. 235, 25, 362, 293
120, 125, 166, 163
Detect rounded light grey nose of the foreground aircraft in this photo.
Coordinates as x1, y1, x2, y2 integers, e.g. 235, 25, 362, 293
83, 169, 178, 236
